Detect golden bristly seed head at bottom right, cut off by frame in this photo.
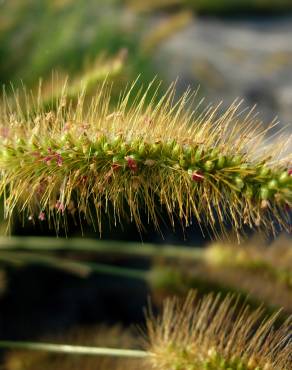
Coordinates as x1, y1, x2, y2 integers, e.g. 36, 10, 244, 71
147, 292, 292, 370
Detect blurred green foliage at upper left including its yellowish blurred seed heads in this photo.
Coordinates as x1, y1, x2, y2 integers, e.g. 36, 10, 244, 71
0, 0, 191, 110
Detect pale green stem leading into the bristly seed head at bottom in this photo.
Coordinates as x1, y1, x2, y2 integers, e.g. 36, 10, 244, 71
0, 340, 148, 358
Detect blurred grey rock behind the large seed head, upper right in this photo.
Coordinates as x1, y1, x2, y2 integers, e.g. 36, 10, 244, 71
155, 17, 292, 131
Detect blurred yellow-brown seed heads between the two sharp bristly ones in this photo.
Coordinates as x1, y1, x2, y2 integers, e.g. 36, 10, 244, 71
151, 238, 292, 314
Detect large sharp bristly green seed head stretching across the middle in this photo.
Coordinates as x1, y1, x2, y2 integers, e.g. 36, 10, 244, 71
0, 83, 292, 237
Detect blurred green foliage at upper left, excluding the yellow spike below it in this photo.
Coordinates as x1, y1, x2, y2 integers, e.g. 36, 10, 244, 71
0, 0, 148, 86
